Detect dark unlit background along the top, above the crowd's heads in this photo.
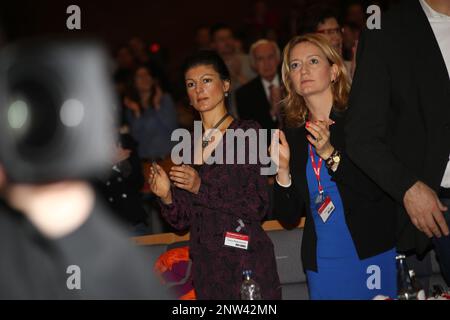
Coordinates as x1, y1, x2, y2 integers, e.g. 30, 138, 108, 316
0, 0, 382, 89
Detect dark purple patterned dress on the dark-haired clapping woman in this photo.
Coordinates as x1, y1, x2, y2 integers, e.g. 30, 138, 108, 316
161, 120, 281, 300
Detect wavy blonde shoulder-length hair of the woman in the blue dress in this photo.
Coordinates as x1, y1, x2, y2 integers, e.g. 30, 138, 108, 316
281, 33, 350, 127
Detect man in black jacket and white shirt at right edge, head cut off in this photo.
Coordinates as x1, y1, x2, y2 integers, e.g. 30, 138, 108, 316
346, 0, 450, 281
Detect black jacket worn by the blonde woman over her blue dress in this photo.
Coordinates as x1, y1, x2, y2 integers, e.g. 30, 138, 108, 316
274, 112, 395, 271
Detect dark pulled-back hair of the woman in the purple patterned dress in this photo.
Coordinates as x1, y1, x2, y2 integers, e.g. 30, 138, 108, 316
183, 50, 231, 82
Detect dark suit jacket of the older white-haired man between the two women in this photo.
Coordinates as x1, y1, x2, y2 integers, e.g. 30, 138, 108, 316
236, 77, 278, 129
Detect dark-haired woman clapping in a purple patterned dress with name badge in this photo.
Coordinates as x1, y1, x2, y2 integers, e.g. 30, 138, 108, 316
149, 51, 281, 299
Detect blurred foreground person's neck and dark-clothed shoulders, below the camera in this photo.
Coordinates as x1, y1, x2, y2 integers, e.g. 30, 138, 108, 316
0, 167, 168, 299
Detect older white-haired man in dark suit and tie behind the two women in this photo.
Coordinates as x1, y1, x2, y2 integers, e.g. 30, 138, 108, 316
236, 40, 281, 129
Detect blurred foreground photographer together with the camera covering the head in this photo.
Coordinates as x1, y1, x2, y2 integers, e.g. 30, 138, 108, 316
0, 39, 165, 299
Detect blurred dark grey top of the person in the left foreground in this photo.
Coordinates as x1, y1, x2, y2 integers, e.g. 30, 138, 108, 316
0, 199, 167, 299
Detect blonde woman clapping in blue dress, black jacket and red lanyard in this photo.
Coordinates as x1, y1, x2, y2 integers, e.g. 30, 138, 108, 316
275, 34, 396, 299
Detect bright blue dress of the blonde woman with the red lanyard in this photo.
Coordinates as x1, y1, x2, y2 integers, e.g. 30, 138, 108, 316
306, 147, 397, 300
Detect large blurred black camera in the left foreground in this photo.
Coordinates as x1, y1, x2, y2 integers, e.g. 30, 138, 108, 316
0, 41, 116, 183
